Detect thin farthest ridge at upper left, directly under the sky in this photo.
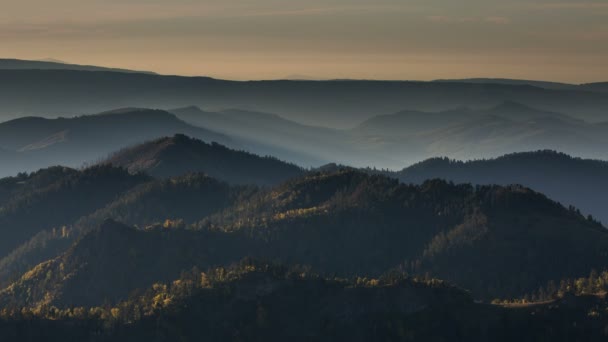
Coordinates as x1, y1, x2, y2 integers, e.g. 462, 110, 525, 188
0, 58, 154, 74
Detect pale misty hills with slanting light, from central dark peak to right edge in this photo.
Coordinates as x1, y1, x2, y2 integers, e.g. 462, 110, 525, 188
172, 101, 608, 169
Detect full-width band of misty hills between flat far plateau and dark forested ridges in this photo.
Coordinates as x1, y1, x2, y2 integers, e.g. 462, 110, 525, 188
0, 102, 608, 176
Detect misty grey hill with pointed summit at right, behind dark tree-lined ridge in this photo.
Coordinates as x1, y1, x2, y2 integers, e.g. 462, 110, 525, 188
353, 102, 608, 167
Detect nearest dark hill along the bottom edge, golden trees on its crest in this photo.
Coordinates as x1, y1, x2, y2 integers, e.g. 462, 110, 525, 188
0, 261, 608, 342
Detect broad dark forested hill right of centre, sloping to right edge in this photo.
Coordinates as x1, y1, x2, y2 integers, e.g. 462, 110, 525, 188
196, 171, 608, 299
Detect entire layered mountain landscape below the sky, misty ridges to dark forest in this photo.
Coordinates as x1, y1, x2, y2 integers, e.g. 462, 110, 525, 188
0, 60, 608, 342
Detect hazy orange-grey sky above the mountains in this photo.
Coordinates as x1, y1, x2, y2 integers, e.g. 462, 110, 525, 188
0, 0, 608, 82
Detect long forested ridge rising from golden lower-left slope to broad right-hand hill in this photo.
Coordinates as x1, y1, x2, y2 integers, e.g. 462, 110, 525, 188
0, 170, 608, 306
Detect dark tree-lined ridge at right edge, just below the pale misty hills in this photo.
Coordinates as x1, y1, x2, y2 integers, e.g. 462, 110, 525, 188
388, 151, 608, 223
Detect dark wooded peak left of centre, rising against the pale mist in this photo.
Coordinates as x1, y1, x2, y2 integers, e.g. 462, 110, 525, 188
102, 134, 303, 185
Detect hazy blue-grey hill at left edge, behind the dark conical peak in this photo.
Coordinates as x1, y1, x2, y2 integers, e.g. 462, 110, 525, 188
0, 109, 234, 176
